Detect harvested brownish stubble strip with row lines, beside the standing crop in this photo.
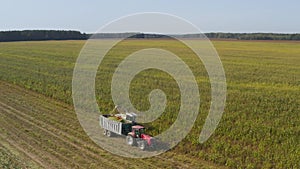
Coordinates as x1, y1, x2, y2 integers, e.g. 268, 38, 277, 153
0, 81, 220, 168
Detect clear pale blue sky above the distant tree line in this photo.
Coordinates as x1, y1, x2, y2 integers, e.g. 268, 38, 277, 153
0, 0, 300, 33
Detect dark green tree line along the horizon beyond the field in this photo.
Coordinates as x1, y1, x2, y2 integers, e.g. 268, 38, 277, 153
0, 30, 300, 42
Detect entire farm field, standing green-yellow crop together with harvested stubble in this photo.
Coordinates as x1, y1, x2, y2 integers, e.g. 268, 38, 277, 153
0, 40, 300, 168
